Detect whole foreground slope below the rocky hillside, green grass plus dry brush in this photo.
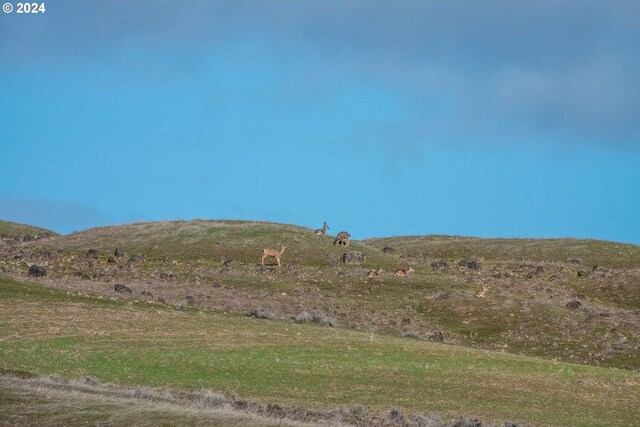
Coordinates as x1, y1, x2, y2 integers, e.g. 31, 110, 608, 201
0, 278, 640, 427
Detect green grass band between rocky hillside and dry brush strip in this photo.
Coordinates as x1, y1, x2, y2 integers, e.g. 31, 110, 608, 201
0, 279, 640, 426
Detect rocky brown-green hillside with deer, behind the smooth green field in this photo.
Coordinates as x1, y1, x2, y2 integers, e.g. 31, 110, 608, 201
0, 220, 640, 369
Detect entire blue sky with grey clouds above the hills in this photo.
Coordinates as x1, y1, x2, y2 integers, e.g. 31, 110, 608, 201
0, 0, 640, 244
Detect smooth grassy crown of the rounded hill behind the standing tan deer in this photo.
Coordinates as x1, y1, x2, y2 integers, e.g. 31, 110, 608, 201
36, 220, 396, 267
